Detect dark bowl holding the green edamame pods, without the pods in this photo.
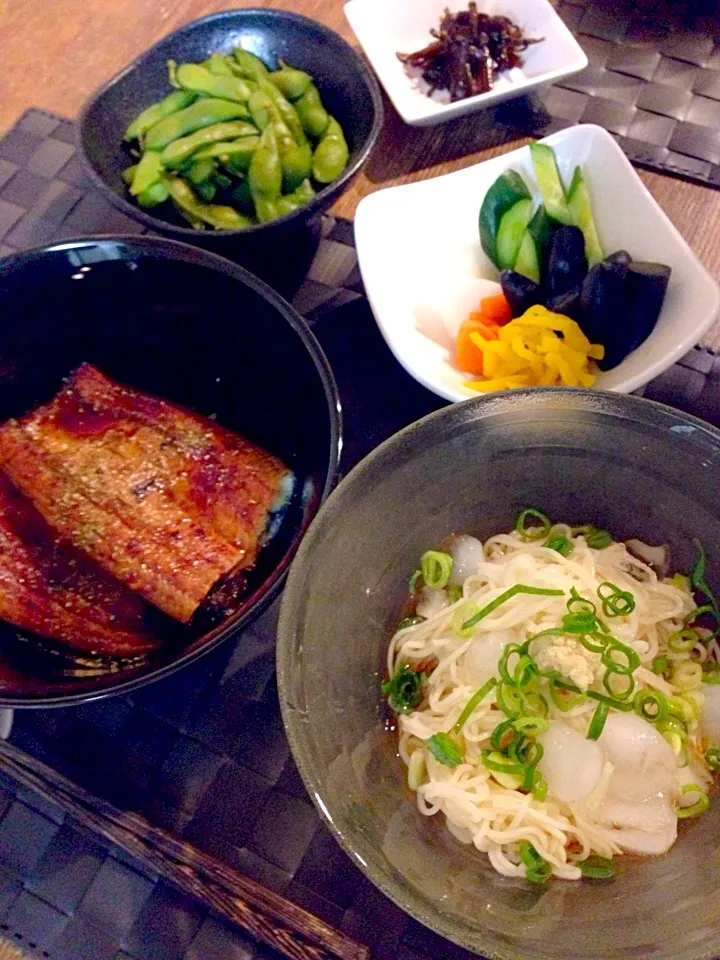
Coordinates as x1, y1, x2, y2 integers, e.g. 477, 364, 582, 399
78, 9, 382, 284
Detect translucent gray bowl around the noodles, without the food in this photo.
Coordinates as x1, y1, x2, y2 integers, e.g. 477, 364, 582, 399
278, 389, 720, 960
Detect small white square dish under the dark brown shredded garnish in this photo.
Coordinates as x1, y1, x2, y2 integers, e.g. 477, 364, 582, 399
345, 0, 588, 126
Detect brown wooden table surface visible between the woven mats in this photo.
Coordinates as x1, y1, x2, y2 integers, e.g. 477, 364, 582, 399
0, 0, 720, 342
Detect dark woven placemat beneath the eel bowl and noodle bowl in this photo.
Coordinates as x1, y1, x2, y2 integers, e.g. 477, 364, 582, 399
0, 110, 720, 960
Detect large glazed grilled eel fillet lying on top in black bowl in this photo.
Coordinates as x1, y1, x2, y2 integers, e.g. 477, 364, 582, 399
0, 364, 292, 622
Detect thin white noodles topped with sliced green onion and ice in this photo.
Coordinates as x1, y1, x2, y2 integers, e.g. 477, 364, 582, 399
383, 510, 720, 882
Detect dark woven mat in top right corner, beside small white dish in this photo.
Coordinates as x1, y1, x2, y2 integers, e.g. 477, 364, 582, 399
520, 0, 720, 187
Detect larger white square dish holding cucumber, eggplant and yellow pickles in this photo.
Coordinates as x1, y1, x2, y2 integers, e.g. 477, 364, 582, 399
355, 125, 720, 401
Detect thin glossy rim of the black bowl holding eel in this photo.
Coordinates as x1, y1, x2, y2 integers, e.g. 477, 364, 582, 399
0, 234, 343, 709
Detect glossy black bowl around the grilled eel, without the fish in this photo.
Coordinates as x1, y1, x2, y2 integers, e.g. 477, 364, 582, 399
0, 237, 340, 706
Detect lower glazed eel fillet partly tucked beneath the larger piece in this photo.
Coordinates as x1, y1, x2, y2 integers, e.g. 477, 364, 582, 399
0, 473, 158, 657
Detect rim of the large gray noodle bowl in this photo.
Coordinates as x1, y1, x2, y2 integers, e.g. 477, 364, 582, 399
276, 387, 720, 960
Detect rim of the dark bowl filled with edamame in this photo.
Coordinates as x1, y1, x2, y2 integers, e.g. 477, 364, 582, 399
75, 7, 384, 243
